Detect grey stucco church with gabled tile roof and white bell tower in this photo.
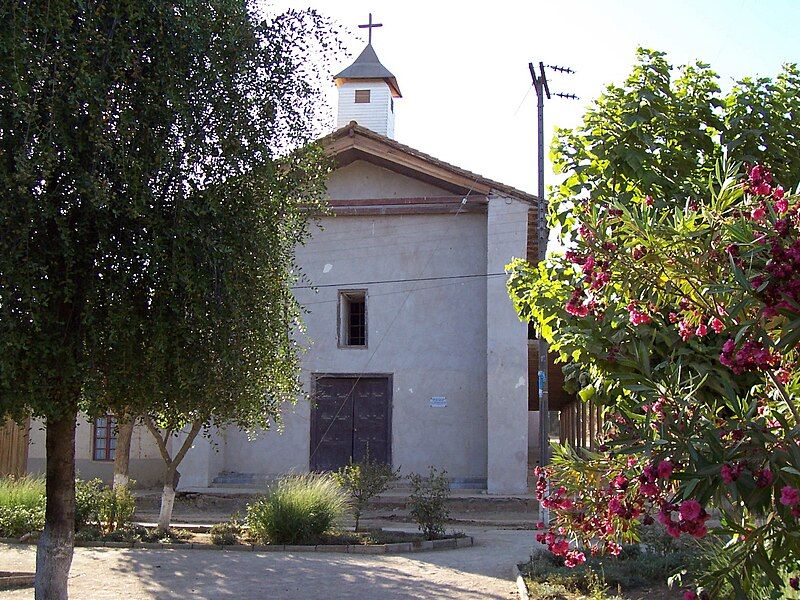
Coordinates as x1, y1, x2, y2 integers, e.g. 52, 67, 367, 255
17, 21, 576, 493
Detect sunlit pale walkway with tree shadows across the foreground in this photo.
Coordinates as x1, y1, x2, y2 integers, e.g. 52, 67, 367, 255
0, 529, 535, 600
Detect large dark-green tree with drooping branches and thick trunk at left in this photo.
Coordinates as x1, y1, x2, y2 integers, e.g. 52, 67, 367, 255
0, 0, 335, 598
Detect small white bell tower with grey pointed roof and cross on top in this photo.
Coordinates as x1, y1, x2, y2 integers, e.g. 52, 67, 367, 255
334, 13, 402, 138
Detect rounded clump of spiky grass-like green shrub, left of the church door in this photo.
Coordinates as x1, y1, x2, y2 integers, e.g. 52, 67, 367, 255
247, 473, 347, 544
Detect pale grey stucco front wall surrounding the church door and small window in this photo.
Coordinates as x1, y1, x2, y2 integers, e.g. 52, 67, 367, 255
225, 209, 486, 479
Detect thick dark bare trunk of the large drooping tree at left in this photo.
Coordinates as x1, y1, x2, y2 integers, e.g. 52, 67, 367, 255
35, 412, 77, 600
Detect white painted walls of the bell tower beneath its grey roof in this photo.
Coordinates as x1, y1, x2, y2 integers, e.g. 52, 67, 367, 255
336, 80, 394, 138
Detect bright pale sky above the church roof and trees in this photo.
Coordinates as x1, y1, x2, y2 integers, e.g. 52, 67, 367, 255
268, 0, 800, 192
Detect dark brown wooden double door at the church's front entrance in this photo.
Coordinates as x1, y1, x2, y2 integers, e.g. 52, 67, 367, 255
309, 375, 392, 471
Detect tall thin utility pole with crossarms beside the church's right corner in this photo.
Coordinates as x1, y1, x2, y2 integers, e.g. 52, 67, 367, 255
528, 62, 577, 523
